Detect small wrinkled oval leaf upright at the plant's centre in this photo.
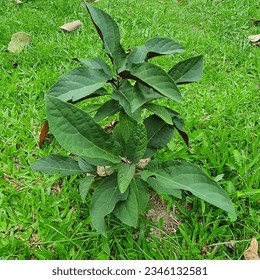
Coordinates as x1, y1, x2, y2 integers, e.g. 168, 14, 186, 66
125, 124, 147, 163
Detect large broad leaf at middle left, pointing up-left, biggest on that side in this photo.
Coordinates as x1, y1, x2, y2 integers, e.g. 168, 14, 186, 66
46, 95, 120, 163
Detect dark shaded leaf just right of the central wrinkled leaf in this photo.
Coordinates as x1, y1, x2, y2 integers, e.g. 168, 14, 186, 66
144, 115, 174, 158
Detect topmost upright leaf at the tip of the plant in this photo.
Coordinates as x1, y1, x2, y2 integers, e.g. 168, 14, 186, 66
85, 3, 126, 69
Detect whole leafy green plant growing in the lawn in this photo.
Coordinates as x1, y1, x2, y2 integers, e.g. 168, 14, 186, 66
31, 3, 236, 235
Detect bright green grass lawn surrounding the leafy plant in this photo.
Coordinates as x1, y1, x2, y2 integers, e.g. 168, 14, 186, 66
0, 0, 260, 260
